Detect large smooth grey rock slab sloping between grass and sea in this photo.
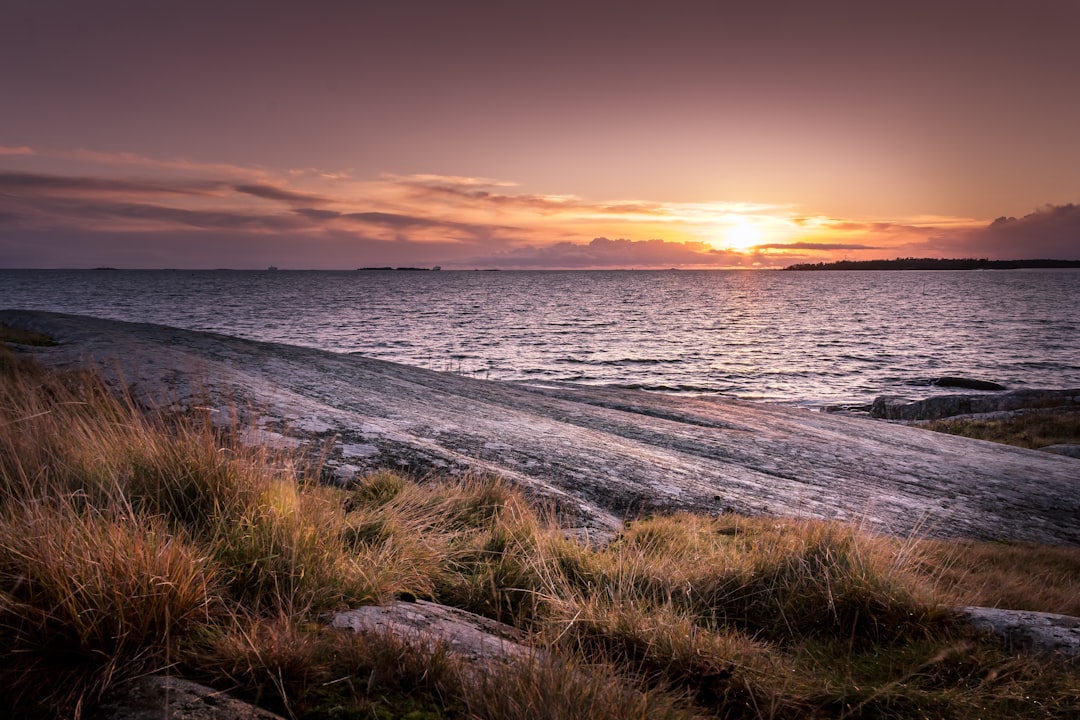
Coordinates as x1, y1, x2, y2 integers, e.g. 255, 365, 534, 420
0, 311, 1080, 545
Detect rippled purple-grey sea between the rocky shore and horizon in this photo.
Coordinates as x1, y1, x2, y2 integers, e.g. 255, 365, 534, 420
0, 270, 1080, 406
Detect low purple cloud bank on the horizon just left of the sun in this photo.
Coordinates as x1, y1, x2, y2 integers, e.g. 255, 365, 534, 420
457, 237, 747, 269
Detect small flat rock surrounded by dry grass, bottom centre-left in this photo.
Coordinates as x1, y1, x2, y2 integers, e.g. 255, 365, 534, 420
330, 600, 539, 669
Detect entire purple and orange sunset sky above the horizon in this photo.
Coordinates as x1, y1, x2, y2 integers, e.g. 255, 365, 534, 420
0, 0, 1080, 269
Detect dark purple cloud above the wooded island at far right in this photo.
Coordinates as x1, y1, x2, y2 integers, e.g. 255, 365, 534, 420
928, 203, 1080, 260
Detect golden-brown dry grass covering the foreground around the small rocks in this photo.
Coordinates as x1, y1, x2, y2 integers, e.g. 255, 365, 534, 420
0, 363, 1080, 720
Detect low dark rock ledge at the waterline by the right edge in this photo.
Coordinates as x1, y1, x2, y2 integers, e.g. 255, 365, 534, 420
870, 389, 1080, 422
